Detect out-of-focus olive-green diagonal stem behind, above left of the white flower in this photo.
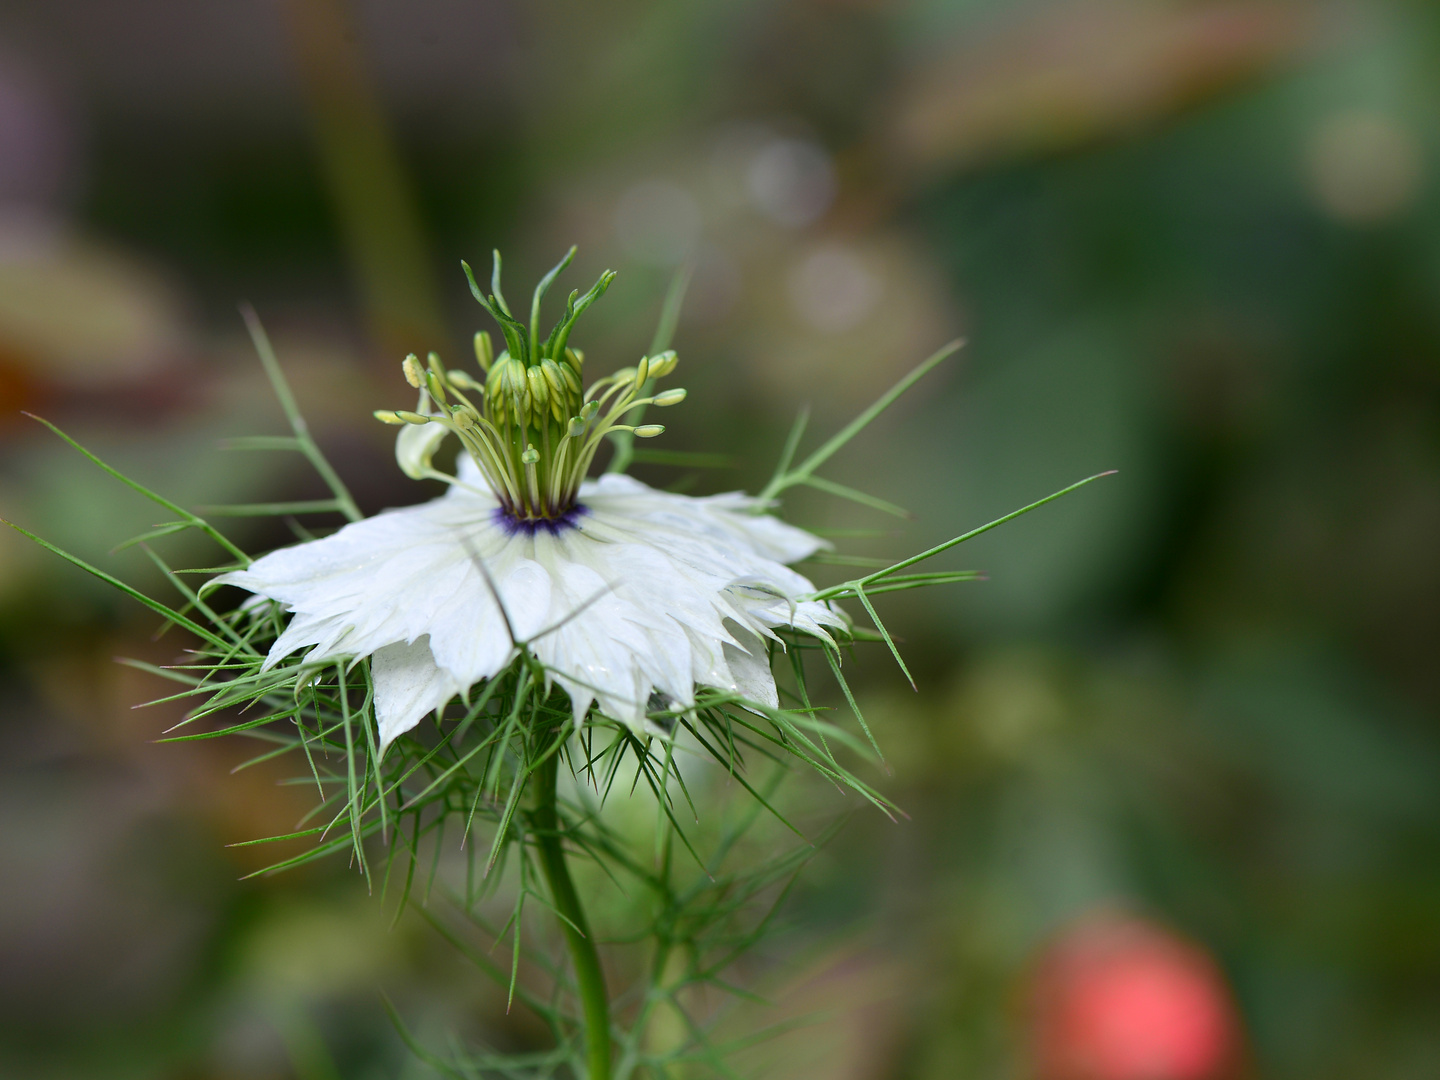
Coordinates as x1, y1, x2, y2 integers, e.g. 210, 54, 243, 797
282, 0, 446, 356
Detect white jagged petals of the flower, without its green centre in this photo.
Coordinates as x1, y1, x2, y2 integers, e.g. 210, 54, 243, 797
219, 451, 845, 746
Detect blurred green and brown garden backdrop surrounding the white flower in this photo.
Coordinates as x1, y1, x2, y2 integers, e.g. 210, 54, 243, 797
0, 0, 1440, 1080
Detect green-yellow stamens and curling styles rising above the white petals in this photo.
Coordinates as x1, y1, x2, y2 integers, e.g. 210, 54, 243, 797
376, 248, 685, 521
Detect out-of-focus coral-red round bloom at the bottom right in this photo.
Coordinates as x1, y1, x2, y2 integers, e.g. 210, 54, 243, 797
1031, 913, 1240, 1080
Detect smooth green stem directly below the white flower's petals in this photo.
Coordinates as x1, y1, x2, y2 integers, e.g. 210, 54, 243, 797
530, 752, 611, 1080
